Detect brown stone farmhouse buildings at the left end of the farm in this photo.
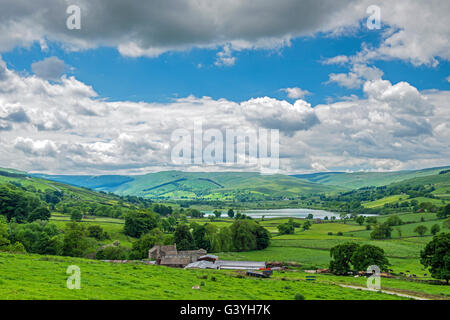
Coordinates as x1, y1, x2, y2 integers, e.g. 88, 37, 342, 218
148, 244, 207, 267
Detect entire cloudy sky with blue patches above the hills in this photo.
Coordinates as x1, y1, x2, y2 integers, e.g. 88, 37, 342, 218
0, 0, 450, 174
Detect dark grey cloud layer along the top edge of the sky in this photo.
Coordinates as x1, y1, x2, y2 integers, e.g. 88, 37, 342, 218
0, 0, 450, 69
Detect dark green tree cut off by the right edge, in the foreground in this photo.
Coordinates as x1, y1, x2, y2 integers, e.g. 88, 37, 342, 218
420, 233, 450, 284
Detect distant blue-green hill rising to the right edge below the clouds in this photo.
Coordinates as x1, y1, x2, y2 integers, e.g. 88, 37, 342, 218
293, 167, 450, 189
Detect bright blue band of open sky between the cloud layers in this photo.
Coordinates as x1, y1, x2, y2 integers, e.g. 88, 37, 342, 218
3, 29, 450, 106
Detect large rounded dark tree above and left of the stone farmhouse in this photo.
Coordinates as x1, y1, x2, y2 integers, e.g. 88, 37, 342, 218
123, 211, 160, 238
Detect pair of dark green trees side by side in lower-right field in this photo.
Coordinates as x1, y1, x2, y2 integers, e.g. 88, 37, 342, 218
329, 242, 389, 275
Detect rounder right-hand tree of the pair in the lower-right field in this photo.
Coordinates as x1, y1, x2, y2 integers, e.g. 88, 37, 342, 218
351, 244, 389, 271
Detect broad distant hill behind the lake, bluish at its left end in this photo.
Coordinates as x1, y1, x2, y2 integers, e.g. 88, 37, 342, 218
30, 171, 342, 200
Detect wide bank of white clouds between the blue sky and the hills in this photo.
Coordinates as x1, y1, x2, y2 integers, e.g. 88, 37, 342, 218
0, 56, 450, 174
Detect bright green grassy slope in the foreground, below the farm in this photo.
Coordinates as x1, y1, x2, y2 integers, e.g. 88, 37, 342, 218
0, 253, 412, 300
